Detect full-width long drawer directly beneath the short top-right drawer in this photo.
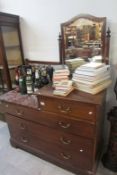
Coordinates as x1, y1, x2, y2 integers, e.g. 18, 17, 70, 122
5, 103, 95, 138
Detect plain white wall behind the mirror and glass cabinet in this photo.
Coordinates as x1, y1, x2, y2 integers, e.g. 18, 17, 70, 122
0, 0, 117, 106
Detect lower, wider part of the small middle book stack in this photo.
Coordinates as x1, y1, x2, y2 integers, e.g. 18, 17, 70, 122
53, 80, 74, 96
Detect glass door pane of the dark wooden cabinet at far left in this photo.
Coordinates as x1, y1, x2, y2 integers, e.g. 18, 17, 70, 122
1, 26, 22, 87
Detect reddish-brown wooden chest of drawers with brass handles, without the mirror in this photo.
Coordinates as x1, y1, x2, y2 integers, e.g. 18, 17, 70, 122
2, 87, 105, 174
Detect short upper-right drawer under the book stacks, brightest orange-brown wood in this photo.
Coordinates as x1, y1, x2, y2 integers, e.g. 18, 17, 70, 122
39, 96, 96, 122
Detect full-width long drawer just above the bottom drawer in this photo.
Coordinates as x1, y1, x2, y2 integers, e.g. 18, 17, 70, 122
6, 115, 93, 157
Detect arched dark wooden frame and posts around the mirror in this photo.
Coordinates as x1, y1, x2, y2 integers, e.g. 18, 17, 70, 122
59, 14, 110, 64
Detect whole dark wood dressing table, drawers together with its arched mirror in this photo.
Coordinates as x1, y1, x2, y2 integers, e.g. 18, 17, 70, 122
0, 15, 109, 175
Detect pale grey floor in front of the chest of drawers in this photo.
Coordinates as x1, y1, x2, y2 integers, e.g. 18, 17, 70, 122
0, 121, 117, 175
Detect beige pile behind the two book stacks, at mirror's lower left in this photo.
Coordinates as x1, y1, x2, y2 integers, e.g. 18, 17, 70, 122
65, 58, 86, 73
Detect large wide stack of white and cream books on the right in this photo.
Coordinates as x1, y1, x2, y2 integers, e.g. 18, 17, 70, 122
72, 62, 111, 94
